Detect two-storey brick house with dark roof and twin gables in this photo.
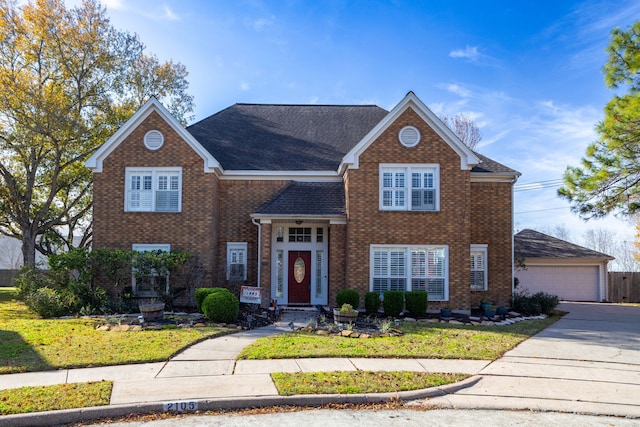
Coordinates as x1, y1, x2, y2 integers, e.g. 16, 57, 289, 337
86, 92, 519, 310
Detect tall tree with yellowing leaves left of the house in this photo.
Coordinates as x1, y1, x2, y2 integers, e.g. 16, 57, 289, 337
0, 0, 193, 264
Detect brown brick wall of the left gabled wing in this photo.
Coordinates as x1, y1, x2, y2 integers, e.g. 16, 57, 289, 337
93, 112, 219, 292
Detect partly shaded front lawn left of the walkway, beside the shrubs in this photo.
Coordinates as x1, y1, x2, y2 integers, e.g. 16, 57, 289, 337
0, 288, 235, 374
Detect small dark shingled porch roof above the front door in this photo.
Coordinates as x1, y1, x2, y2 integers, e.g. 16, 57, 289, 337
251, 181, 346, 218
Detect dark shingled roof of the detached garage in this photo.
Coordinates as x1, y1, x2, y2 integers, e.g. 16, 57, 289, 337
514, 229, 615, 260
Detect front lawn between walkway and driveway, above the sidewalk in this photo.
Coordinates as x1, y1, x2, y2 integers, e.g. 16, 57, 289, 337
238, 316, 559, 360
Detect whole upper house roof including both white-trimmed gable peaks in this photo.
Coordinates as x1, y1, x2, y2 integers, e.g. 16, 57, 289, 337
85, 92, 519, 180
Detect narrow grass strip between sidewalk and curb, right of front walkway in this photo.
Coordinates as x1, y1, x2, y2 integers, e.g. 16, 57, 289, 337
271, 371, 469, 396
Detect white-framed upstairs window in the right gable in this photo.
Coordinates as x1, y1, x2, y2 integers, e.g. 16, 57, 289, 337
380, 165, 440, 211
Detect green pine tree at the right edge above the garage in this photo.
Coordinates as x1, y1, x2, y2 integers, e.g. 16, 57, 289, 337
558, 21, 640, 219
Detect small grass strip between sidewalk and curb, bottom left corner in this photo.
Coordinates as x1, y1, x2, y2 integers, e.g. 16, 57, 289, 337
0, 381, 113, 415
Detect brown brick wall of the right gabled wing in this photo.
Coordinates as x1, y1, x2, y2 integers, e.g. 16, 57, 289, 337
345, 105, 511, 309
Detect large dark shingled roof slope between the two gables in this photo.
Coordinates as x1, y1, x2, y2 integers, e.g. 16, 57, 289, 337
187, 104, 387, 171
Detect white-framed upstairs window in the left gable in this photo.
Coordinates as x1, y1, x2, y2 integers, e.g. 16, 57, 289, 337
125, 168, 182, 212
